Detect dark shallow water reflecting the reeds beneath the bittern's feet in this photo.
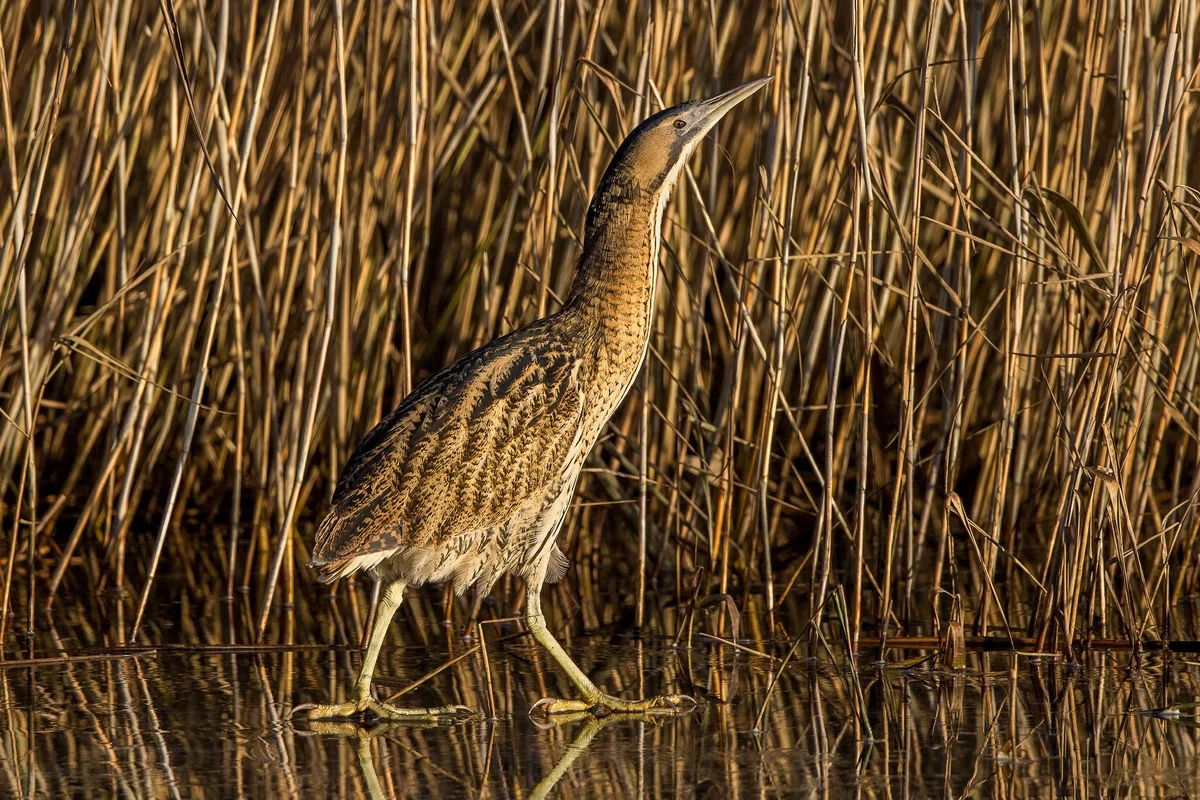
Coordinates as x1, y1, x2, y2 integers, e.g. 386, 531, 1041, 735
0, 637, 1200, 799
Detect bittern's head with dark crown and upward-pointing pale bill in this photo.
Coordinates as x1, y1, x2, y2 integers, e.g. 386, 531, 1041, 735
588, 78, 770, 236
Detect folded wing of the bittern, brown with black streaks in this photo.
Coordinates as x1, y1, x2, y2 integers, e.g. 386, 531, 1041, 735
313, 324, 583, 579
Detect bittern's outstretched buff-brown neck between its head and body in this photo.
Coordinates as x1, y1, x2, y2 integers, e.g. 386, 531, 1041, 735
566, 174, 673, 381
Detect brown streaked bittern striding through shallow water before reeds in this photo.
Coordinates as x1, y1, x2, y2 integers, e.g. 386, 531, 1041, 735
300, 78, 770, 720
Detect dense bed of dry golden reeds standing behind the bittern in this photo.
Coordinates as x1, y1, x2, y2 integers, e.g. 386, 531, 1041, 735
0, 0, 1200, 652
